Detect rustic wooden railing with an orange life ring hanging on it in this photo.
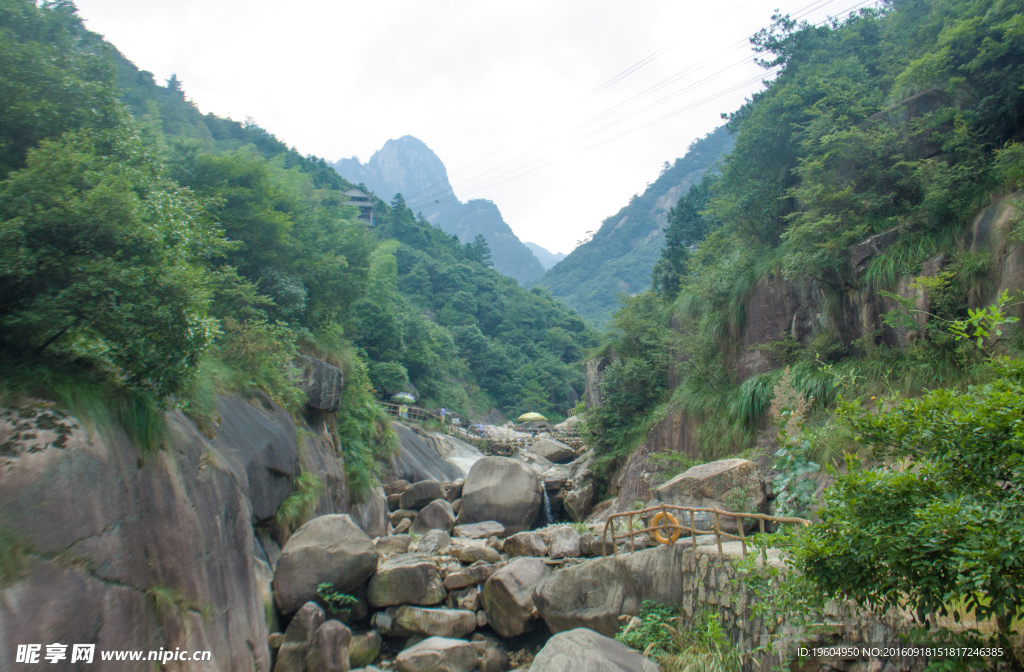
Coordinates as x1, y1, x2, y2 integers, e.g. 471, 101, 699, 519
601, 504, 811, 563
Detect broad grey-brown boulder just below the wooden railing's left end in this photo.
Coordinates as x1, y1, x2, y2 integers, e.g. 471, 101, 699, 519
528, 544, 686, 637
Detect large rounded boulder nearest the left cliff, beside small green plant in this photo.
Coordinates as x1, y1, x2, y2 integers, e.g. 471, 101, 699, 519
273, 514, 378, 616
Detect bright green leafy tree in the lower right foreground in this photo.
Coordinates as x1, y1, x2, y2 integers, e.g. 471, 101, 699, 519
794, 360, 1024, 635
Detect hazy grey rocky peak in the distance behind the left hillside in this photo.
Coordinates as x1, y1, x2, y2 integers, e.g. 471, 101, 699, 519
333, 135, 545, 284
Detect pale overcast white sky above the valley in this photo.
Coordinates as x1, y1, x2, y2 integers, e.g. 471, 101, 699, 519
76, 0, 872, 253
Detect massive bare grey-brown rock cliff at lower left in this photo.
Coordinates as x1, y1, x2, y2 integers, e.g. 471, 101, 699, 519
0, 389, 364, 672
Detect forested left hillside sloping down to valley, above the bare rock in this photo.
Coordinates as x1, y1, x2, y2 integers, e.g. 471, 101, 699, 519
0, 0, 593, 477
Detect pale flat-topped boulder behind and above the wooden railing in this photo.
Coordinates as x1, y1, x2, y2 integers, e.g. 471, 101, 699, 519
657, 458, 767, 531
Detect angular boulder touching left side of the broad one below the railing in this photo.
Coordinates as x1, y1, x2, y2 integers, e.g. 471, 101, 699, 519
481, 557, 552, 637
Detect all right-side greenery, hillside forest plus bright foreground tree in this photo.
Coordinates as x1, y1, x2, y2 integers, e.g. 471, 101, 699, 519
587, 0, 1024, 655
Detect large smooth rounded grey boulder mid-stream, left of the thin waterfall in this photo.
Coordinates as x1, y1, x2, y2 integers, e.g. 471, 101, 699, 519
458, 457, 541, 533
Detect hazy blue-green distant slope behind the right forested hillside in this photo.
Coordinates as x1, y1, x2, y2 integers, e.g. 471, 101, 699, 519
534, 126, 733, 327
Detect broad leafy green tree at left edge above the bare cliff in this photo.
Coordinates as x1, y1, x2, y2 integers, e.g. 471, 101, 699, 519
0, 122, 227, 397
